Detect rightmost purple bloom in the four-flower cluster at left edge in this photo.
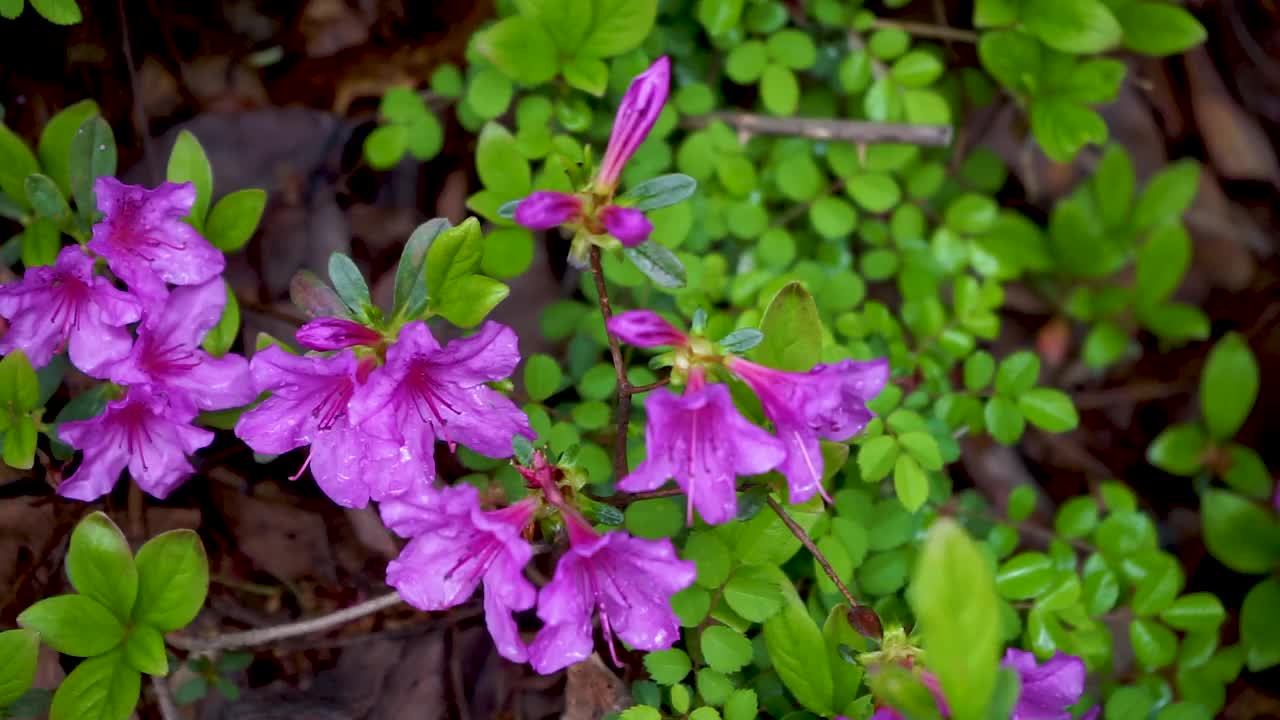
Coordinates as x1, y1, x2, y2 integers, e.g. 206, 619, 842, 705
108, 278, 257, 414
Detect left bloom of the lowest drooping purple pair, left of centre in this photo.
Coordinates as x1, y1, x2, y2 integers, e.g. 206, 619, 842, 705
380, 484, 538, 662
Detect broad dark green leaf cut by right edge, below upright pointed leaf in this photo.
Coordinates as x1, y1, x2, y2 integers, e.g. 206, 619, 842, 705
1201, 489, 1280, 573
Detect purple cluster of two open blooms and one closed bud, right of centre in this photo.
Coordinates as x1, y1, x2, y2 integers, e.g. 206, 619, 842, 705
608, 310, 890, 524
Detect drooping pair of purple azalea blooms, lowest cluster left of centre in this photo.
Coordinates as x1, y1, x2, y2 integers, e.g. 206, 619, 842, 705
380, 454, 696, 674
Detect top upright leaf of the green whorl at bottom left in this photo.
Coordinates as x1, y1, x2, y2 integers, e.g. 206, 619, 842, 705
67, 512, 138, 623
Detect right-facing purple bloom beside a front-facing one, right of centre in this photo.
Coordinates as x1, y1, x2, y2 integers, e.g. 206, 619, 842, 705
726, 357, 890, 502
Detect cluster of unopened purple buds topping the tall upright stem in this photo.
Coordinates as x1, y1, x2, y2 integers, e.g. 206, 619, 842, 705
515, 56, 671, 247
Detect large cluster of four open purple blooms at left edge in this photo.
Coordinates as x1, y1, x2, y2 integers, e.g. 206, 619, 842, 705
0, 177, 256, 501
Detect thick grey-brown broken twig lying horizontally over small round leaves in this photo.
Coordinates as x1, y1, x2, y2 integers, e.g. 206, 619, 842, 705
681, 110, 954, 147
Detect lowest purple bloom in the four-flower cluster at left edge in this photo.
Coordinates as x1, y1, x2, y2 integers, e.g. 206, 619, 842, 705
58, 384, 214, 501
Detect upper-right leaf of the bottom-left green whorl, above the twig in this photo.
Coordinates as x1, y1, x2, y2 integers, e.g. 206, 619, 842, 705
133, 530, 209, 633
